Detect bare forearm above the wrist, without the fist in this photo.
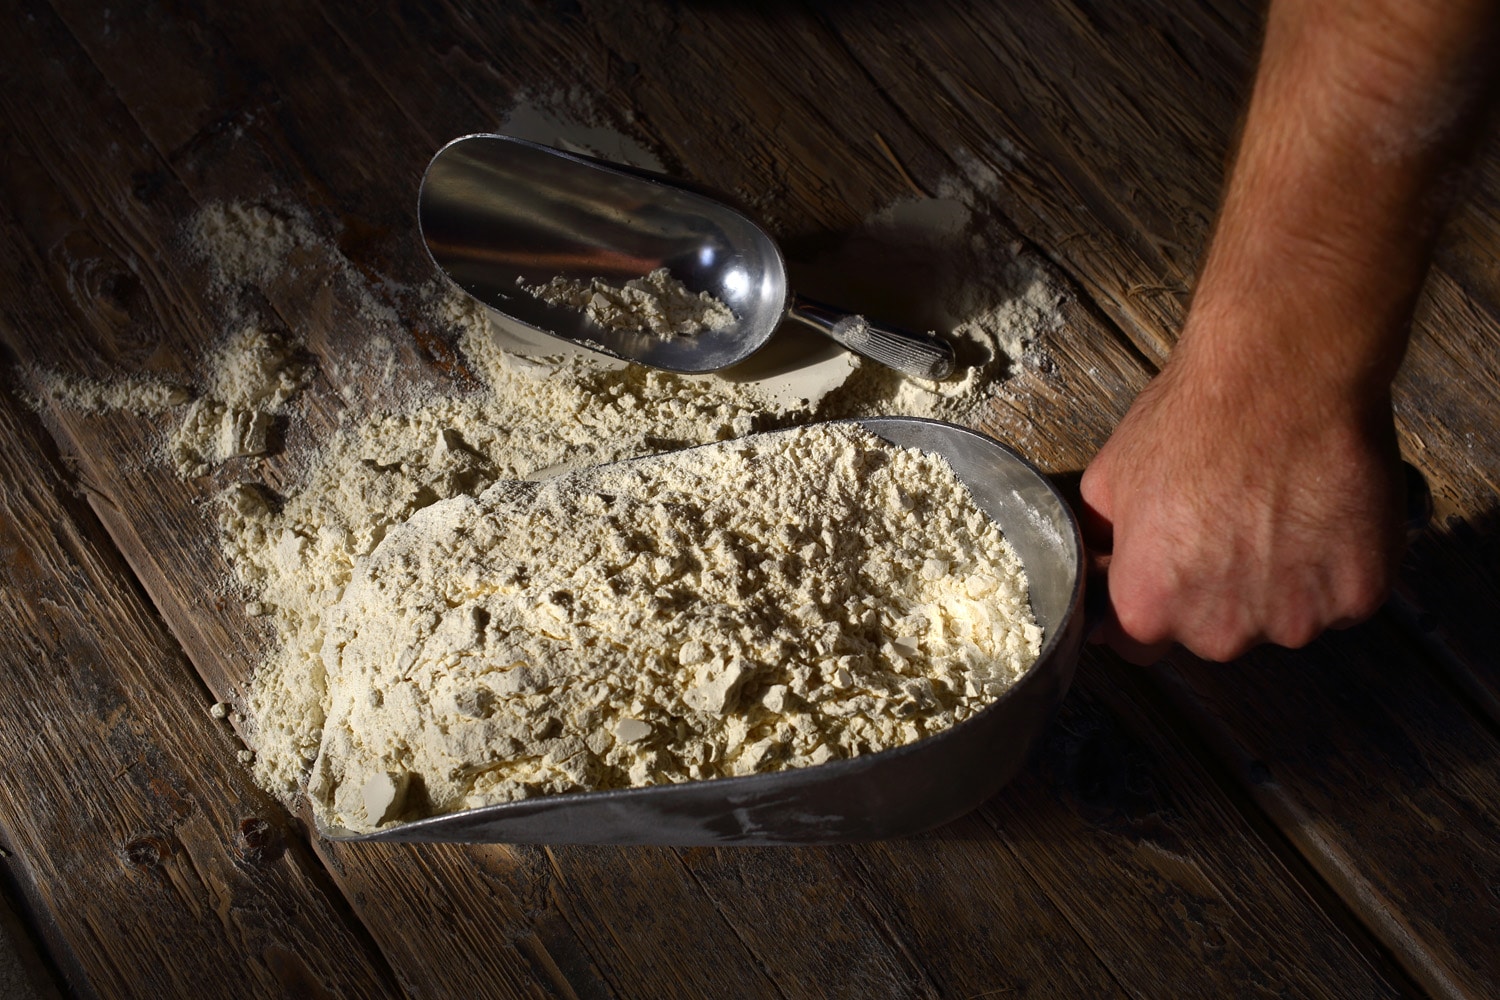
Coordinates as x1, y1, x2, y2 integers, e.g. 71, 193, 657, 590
1179, 0, 1500, 405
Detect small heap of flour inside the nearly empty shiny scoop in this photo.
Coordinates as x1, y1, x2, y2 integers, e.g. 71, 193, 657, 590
522, 267, 735, 337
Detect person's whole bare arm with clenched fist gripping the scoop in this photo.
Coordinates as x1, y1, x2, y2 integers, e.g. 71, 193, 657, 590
1080, 0, 1500, 661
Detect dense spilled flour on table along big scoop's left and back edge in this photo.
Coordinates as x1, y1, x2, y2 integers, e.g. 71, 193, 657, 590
219, 291, 810, 796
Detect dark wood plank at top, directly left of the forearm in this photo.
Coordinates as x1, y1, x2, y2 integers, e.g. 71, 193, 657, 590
825, 0, 1254, 361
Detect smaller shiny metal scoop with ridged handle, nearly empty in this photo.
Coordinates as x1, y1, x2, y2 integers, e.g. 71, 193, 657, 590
417, 135, 954, 379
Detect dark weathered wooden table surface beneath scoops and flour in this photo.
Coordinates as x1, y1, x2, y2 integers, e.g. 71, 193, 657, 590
0, 0, 1500, 1000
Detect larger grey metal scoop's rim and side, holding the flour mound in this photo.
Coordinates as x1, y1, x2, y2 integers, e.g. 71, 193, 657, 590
320, 417, 1085, 846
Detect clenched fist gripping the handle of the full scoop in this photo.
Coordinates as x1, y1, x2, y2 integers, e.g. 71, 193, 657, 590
1082, 341, 1404, 663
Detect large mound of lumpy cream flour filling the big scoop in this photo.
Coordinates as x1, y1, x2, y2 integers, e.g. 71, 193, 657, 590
308, 424, 1041, 831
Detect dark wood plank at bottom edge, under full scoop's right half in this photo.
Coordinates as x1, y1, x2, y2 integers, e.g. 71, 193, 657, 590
669, 839, 1128, 1000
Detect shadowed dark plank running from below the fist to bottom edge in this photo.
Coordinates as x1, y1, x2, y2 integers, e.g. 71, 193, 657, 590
981, 657, 1412, 997
